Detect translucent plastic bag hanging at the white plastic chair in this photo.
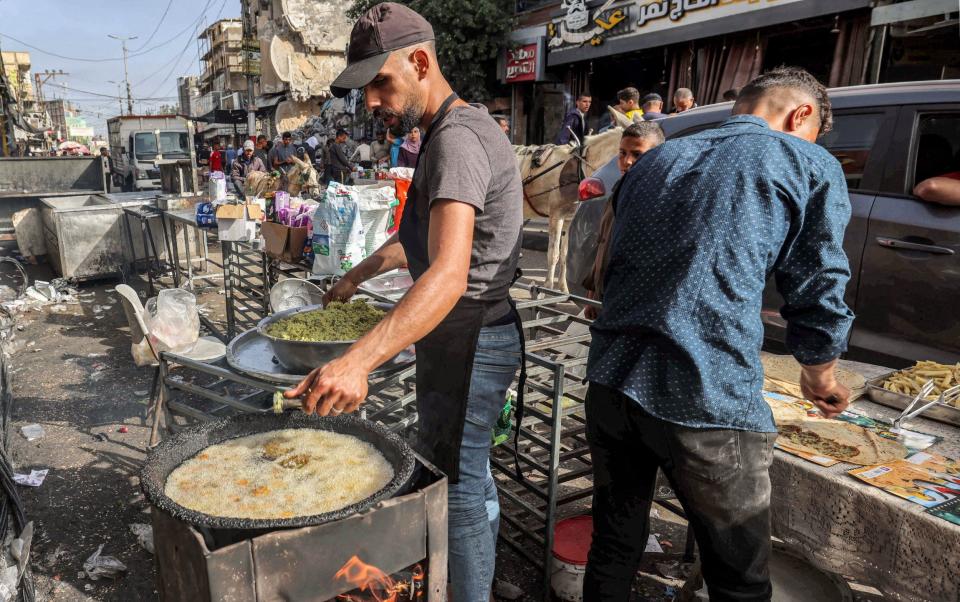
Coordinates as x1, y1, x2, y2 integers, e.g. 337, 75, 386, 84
143, 288, 200, 353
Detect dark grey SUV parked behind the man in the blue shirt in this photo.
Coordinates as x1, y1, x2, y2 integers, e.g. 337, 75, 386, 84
567, 80, 960, 367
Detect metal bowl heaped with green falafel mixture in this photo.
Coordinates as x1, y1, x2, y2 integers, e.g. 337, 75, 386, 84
226, 300, 416, 384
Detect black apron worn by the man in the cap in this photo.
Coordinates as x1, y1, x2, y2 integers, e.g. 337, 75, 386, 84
399, 94, 526, 483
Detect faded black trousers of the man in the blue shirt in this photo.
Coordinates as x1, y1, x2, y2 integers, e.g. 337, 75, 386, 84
583, 383, 776, 602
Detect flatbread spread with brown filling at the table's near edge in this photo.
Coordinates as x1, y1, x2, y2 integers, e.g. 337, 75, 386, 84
777, 419, 907, 466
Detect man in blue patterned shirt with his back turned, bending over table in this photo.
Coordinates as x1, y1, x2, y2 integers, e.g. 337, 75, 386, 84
584, 67, 853, 602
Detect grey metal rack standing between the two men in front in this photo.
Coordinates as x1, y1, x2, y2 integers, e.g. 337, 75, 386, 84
490, 283, 597, 592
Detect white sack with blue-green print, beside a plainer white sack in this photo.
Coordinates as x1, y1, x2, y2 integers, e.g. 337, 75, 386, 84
311, 182, 366, 276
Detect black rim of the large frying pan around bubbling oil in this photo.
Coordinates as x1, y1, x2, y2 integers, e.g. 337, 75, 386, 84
140, 412, 416, 530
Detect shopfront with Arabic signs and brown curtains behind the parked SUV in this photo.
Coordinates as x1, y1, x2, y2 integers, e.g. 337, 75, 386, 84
501, 0, 960, 144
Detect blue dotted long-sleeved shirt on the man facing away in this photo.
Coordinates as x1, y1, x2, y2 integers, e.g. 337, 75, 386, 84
587, 115, 853, 432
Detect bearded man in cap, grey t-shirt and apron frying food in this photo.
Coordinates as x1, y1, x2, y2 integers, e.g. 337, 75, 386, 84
286, 3, 523, 602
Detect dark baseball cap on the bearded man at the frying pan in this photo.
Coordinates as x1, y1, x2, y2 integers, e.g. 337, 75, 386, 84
330, 2, 435, 98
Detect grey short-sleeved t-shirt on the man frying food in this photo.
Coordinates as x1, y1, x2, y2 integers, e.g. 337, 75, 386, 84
414, 105, 523, 301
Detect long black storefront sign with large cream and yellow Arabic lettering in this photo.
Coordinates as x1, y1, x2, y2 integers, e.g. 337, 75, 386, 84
547, 0, 800, 50
